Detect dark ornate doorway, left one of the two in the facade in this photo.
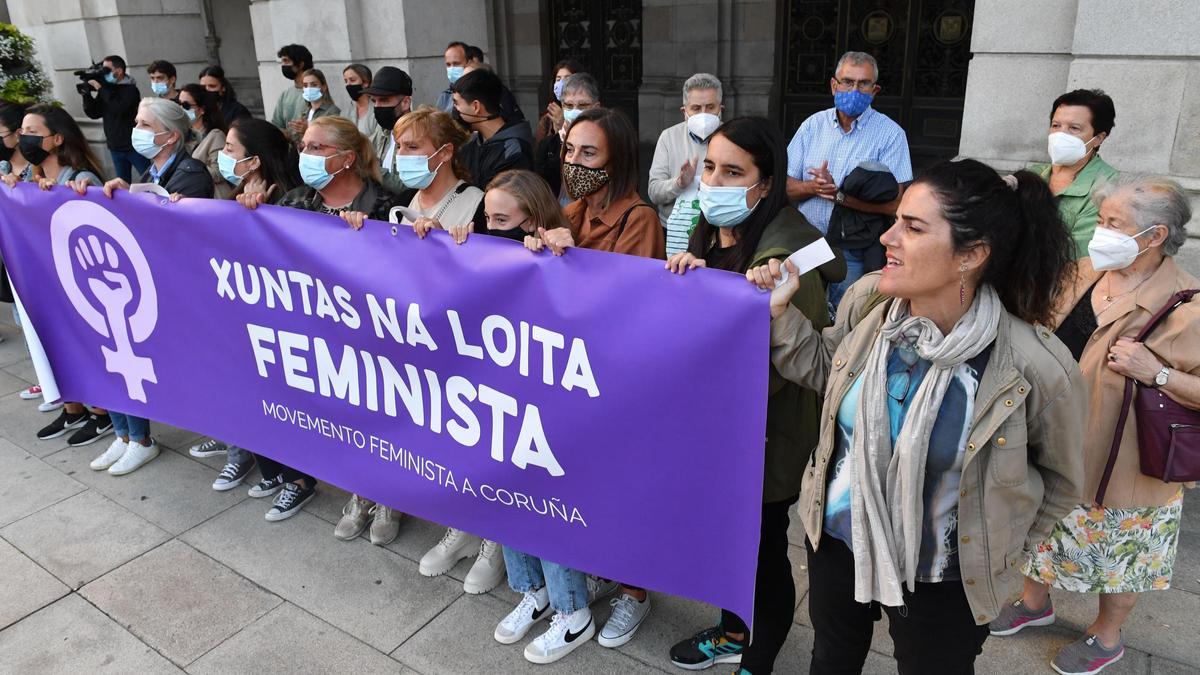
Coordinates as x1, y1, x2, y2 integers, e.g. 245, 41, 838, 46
539, 0, 642, 129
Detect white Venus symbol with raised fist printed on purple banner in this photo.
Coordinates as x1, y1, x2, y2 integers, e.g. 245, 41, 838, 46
50, 201, 158, 402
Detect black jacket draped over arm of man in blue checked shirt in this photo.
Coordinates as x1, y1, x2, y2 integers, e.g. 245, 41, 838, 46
826, 162, 900, 266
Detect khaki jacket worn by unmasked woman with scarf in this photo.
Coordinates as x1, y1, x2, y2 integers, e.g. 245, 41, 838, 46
770, 273, 1087, 625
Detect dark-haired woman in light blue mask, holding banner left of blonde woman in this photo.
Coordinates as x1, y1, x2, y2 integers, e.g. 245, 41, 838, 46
184, 117, 300, 491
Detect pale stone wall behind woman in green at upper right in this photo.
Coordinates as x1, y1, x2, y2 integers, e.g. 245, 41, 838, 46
959, 0, 1200, 274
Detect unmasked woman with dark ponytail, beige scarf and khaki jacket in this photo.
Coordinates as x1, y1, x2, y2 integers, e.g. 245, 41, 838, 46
746, 160, 1087, 674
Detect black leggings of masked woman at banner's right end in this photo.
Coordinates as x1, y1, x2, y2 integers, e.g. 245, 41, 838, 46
721, 497, 798, 675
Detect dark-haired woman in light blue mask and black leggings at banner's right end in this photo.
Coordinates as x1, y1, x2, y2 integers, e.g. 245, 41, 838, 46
666, 118, 846, 675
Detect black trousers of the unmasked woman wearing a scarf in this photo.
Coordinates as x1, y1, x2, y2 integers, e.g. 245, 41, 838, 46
806, 534, 988, 675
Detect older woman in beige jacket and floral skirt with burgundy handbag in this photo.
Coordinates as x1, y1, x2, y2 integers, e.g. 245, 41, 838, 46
991, 177, 1200, 675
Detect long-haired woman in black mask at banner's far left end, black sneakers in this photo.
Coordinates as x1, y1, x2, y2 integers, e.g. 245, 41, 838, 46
2, 103, 113, 447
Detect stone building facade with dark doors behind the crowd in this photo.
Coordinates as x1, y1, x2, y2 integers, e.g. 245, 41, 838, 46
0, 0, 1200, 266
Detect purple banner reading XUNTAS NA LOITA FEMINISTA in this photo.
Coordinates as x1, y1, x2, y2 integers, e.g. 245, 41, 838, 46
0, 185, 769, 620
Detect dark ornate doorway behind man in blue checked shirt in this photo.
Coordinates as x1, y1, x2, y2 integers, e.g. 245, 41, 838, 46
776, 0, 974, 172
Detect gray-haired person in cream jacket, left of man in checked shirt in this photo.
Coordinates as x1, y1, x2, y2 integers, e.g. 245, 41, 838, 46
649, 72, 725, 257
